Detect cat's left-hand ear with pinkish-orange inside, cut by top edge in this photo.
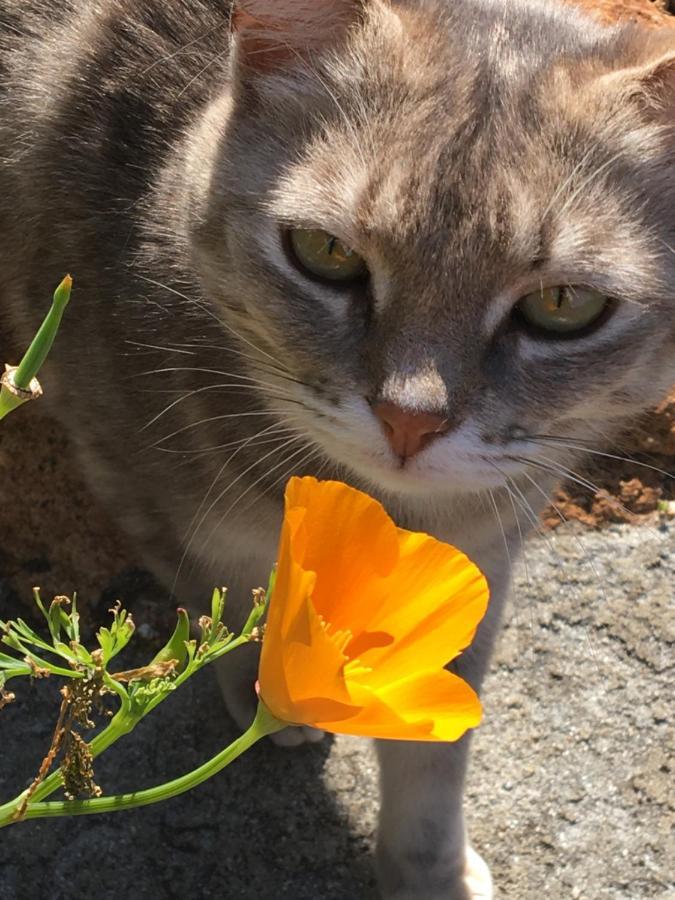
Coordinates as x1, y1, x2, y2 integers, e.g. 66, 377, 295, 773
232, 0, 365, 73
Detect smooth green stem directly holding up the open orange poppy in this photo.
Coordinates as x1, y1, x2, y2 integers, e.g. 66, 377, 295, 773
0, 703, 286, 827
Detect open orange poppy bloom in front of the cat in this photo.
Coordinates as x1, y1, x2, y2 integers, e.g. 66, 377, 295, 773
260, 478, 488, 741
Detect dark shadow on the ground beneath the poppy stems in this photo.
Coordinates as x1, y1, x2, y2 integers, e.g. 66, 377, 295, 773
0, 632, 380, 900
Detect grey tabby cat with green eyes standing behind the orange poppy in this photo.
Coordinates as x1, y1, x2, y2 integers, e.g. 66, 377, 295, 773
0, 0, 675, 900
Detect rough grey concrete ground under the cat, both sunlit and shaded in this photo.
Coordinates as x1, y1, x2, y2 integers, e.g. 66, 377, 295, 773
0, 522, 675, 900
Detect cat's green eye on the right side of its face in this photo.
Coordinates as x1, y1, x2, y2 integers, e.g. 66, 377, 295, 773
517, 286, 610, 335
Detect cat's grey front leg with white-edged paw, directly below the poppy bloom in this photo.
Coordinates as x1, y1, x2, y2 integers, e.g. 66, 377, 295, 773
377, 736, 492, 900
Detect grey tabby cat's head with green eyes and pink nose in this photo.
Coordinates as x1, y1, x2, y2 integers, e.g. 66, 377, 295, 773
189, 0, 675, 496
